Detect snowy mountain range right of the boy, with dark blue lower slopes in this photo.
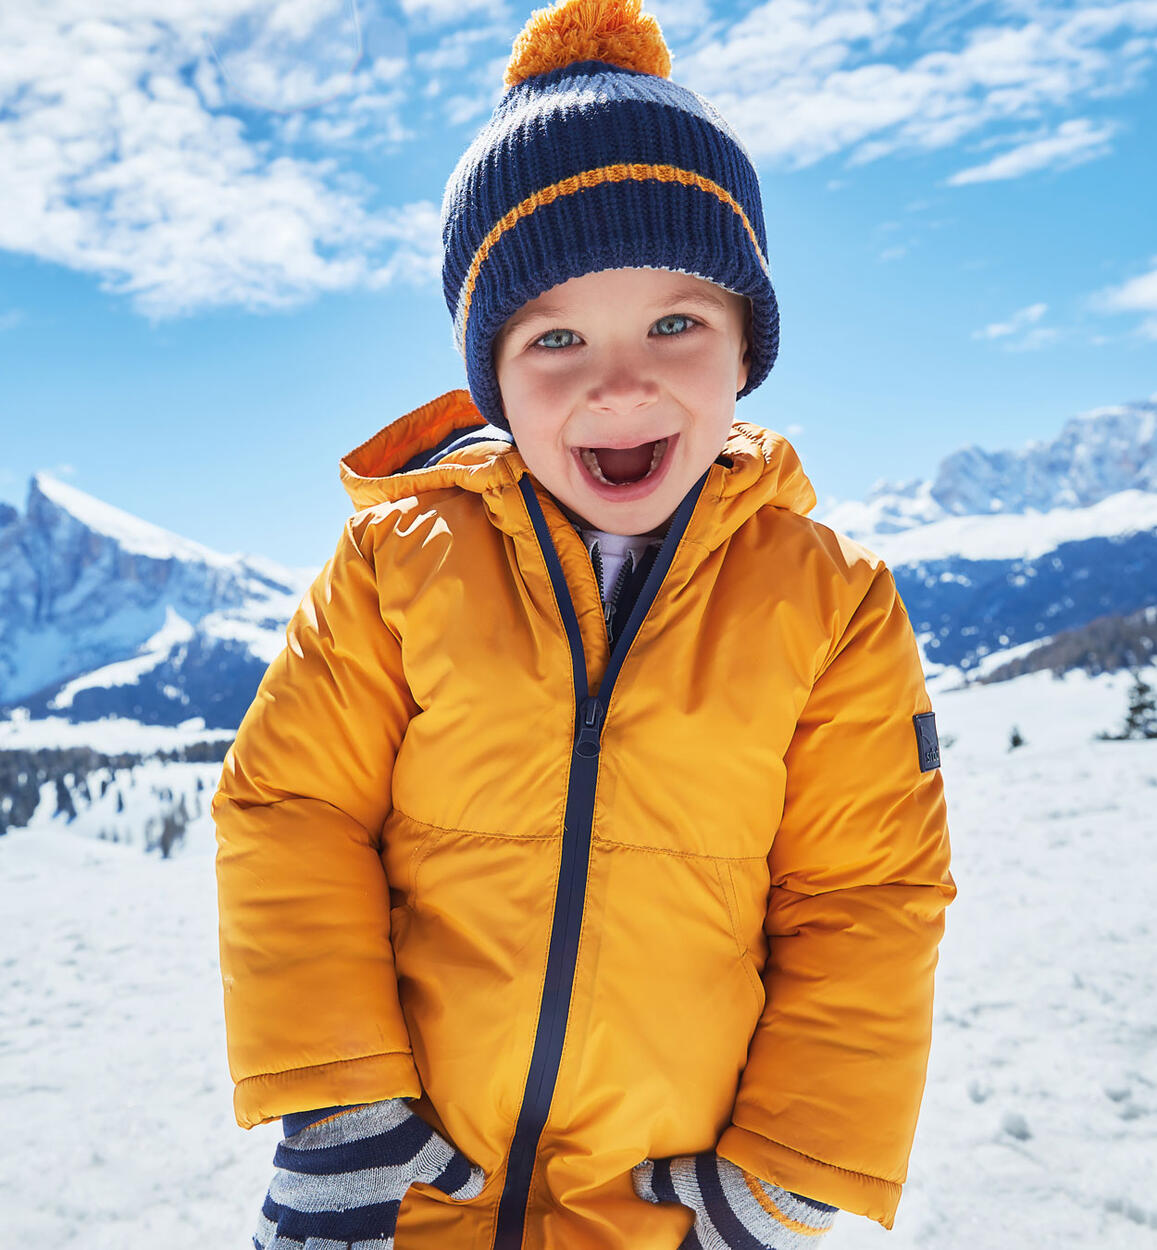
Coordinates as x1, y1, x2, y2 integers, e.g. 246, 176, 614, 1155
821, 403, 1157, 680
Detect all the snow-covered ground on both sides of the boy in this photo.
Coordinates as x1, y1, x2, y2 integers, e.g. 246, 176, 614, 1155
0, 675, 1157, 1250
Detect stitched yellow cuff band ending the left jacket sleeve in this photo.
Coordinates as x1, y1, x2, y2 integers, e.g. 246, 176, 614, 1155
234, 1050, 422, 1129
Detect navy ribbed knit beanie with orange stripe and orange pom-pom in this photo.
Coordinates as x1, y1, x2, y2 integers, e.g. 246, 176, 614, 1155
442, 0, 780, 428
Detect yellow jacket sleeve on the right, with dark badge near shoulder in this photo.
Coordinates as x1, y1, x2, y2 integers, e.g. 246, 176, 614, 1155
717, 566, 956, 1228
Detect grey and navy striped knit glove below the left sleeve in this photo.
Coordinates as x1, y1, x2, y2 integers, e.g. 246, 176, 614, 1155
252, 1099, 484, 1250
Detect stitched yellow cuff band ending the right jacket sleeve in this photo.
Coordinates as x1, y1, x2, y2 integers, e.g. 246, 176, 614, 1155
715, 1125, 900, 1229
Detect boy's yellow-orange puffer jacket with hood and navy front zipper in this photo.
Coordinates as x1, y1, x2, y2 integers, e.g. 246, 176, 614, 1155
214, 391, 953, 1250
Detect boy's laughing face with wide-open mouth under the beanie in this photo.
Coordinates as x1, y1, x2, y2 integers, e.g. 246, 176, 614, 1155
494, 269, 747, 534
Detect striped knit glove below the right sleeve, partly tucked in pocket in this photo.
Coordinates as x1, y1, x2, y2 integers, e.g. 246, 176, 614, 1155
632, 1150, 836, 1250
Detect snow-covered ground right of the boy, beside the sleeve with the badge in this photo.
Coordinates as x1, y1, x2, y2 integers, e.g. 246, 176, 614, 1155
828, 670, 1157, 1250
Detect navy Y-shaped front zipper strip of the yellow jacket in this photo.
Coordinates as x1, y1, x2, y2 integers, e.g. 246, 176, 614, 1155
494, 474, 707, 1250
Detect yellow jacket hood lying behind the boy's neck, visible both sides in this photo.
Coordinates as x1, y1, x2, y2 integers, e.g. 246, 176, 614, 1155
340, 390, 816, 548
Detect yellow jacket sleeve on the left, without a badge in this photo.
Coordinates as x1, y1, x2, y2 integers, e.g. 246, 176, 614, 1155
212, 521, 421, 1128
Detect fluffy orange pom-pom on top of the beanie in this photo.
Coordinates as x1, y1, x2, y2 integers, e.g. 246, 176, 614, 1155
504, 0, 671, 86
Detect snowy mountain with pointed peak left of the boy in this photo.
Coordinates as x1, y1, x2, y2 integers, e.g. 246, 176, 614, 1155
0, 474, 306, 729
